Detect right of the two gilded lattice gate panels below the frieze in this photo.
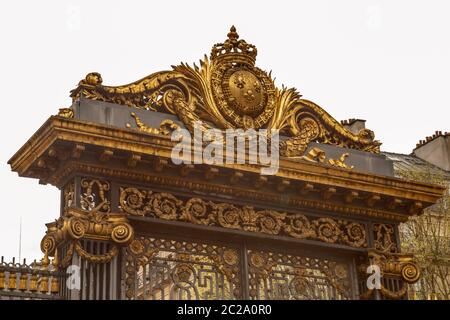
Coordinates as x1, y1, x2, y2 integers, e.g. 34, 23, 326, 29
247, 250, 352, 300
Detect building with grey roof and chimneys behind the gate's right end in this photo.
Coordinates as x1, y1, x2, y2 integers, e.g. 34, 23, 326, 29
384, 131, 450, 300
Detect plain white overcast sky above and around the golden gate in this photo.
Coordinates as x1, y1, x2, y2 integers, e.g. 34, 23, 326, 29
0, 0, 450, 259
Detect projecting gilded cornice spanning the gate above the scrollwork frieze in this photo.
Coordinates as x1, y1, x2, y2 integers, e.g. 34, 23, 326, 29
8, 116, 444, 221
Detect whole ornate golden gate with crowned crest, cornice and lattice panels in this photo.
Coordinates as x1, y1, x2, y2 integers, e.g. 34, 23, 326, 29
6, 27, 443, 299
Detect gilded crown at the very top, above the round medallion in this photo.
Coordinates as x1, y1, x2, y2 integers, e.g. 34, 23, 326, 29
211, 26, 257, 66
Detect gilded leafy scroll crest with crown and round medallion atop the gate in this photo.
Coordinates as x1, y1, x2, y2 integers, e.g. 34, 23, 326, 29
71, 26, 381, 157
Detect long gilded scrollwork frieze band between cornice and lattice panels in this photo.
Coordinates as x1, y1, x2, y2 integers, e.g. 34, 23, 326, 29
119, 187, 368, 248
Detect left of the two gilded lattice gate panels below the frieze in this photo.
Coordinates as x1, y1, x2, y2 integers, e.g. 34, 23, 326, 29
124, 237, 242, 300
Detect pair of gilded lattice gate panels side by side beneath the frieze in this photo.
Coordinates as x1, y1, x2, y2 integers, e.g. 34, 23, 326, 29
124, 232, 354, 300
